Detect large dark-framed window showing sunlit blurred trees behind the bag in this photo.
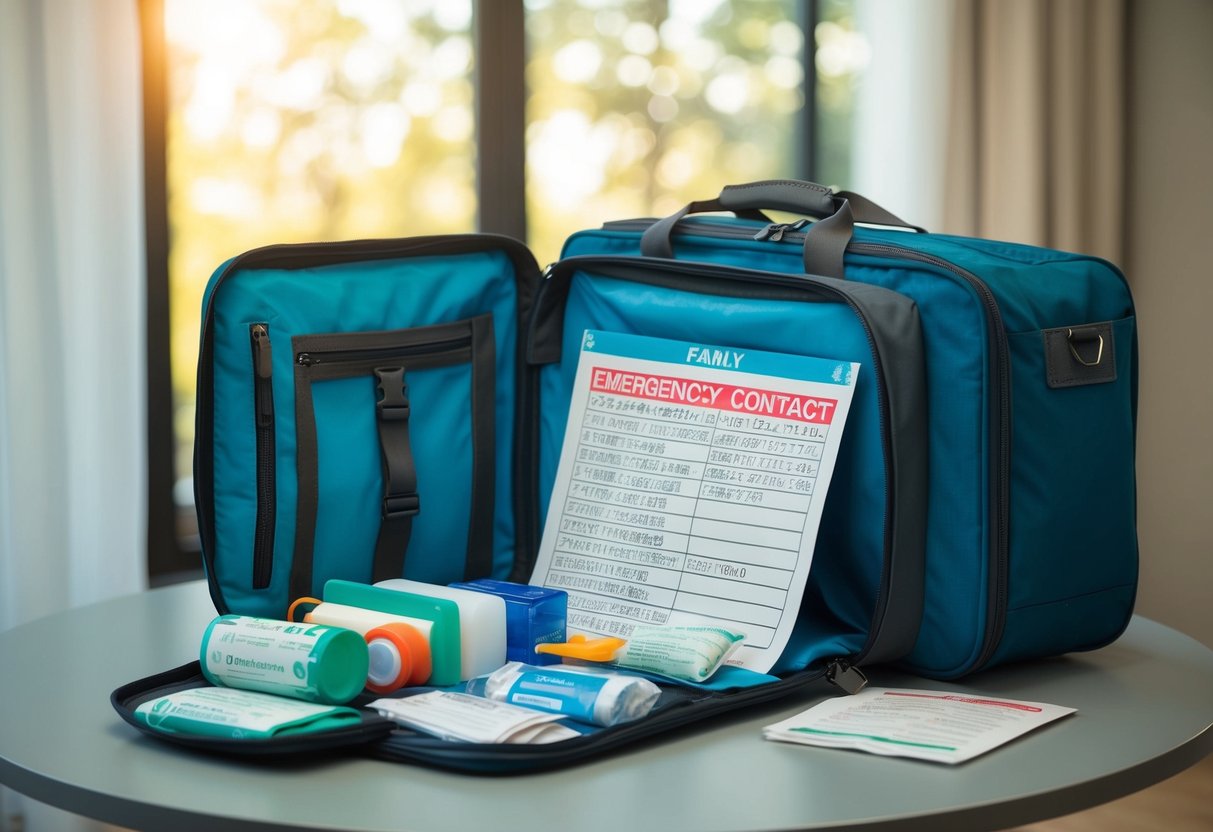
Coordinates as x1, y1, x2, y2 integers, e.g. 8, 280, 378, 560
149, 0, 855, 572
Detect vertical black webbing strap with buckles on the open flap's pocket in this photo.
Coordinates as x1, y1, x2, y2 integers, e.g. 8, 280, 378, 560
371, 367, 421, 581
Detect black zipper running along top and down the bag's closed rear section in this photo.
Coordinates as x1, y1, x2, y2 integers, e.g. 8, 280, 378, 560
603, 220, 1010, 672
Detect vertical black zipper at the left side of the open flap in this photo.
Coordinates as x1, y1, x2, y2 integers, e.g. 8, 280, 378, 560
249, 323, 278, 589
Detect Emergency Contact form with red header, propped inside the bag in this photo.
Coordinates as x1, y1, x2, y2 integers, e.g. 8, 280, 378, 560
531, 330, 860, 673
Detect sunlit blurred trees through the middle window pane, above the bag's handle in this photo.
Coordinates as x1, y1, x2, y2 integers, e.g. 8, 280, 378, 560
526, 0, 804, 262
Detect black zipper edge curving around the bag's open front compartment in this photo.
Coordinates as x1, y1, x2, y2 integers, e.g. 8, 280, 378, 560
534, 255, 895, 669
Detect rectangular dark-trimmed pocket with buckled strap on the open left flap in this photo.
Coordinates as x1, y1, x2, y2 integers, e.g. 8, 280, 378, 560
290, 314, 496, 598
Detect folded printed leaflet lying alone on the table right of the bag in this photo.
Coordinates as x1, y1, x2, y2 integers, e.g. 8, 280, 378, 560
763, 688, 1075, 764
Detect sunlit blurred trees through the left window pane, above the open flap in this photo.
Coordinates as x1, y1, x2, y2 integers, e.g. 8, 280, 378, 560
165, 0, 475, 489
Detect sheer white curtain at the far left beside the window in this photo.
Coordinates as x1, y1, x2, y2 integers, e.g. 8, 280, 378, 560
0, 0, 147, 832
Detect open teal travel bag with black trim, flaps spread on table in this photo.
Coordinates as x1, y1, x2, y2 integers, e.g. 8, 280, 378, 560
112, 181, 1137, 773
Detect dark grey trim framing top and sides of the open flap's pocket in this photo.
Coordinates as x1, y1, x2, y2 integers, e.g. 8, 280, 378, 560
290, 314, 496, 598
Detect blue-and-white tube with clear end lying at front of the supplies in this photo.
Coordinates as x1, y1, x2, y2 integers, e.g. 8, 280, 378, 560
467, 661, 661, 728
